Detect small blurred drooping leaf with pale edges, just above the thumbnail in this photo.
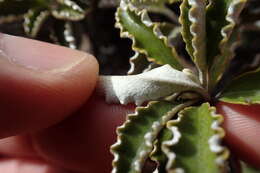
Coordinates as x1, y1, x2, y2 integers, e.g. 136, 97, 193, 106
23, 8, 50, 38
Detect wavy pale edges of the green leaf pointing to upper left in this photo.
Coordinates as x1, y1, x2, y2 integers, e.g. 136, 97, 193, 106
115, 0, 181, 69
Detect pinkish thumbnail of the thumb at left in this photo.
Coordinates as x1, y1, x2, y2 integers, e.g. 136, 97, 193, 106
0, 33, 88, 71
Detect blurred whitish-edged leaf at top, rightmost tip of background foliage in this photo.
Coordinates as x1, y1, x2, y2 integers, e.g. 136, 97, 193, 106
52, 0, 85, 21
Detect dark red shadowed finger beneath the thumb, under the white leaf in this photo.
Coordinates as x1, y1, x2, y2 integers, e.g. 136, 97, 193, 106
33, 96, 134, 173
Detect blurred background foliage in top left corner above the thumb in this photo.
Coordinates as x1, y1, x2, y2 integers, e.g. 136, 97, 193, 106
0, 0, 89, 49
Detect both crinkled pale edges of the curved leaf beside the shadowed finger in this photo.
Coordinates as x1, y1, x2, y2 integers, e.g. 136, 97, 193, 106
110, 100, 197, 173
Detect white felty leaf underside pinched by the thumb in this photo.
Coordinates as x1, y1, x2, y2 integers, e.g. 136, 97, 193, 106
98, 65, 204, 105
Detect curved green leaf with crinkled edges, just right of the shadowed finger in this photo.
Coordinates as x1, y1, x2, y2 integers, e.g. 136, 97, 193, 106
111, 101, 194, 173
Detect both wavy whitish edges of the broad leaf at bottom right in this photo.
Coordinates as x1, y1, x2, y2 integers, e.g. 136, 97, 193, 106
162, 103, 230, 173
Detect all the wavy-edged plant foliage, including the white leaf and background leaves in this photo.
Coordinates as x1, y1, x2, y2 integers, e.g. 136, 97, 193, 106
0, 0, 260, 173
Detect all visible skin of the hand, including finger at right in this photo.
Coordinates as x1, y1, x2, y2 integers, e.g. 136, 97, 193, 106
0, 34, 260, 173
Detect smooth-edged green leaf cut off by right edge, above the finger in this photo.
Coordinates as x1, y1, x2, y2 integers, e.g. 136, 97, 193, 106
220, 69, 260, 104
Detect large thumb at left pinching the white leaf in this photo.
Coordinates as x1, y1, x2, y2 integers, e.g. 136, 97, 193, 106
0, 33, 98, 138
